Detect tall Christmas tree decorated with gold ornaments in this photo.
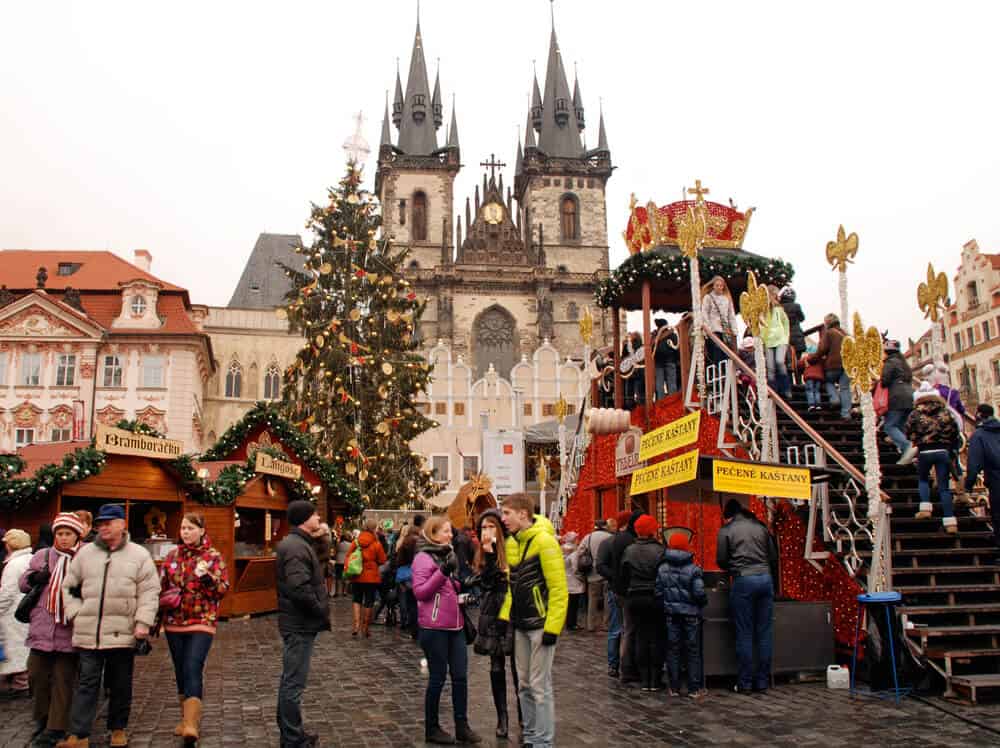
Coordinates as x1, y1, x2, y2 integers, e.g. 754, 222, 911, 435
277, 162, 437, 508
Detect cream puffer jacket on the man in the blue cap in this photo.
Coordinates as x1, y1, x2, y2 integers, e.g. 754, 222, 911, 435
63, 533, 160, 649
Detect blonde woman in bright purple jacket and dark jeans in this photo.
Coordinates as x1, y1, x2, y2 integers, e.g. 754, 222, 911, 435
412, 517, 481, 745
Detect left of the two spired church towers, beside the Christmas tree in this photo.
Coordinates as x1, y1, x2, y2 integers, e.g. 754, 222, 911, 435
375, 18, 460, 275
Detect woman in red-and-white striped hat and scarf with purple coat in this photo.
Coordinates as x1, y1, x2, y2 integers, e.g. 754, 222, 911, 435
20, 512, 84, 746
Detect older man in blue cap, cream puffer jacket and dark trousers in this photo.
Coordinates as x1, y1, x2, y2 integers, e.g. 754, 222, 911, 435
56, 504, 160, 748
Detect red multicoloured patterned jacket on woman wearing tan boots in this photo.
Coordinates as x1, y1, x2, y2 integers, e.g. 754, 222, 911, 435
160, 534, 229, 634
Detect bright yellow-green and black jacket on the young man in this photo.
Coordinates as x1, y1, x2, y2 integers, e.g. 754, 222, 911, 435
500, 514, 569, 636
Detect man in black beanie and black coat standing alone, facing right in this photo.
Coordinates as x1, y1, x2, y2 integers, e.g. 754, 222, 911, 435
275, 501, 330, 748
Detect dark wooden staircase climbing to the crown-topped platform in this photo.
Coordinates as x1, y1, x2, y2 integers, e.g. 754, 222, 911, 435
777, 387, 1000, 703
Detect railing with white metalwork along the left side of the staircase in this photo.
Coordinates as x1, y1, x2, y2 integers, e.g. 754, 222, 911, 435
700, 329, 892, 591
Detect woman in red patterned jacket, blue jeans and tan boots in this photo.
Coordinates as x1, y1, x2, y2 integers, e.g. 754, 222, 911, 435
160, 512, 229, 741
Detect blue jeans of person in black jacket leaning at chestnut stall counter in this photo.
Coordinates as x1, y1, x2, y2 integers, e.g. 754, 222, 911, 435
729, 574, 774, 690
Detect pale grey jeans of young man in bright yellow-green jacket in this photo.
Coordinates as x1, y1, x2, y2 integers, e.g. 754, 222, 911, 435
516, 629, 556, 748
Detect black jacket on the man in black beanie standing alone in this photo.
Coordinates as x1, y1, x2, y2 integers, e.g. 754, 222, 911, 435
275, 527, 330, 634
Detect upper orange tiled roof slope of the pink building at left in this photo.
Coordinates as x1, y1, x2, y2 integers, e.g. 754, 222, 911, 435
0, 249, 186, 293
